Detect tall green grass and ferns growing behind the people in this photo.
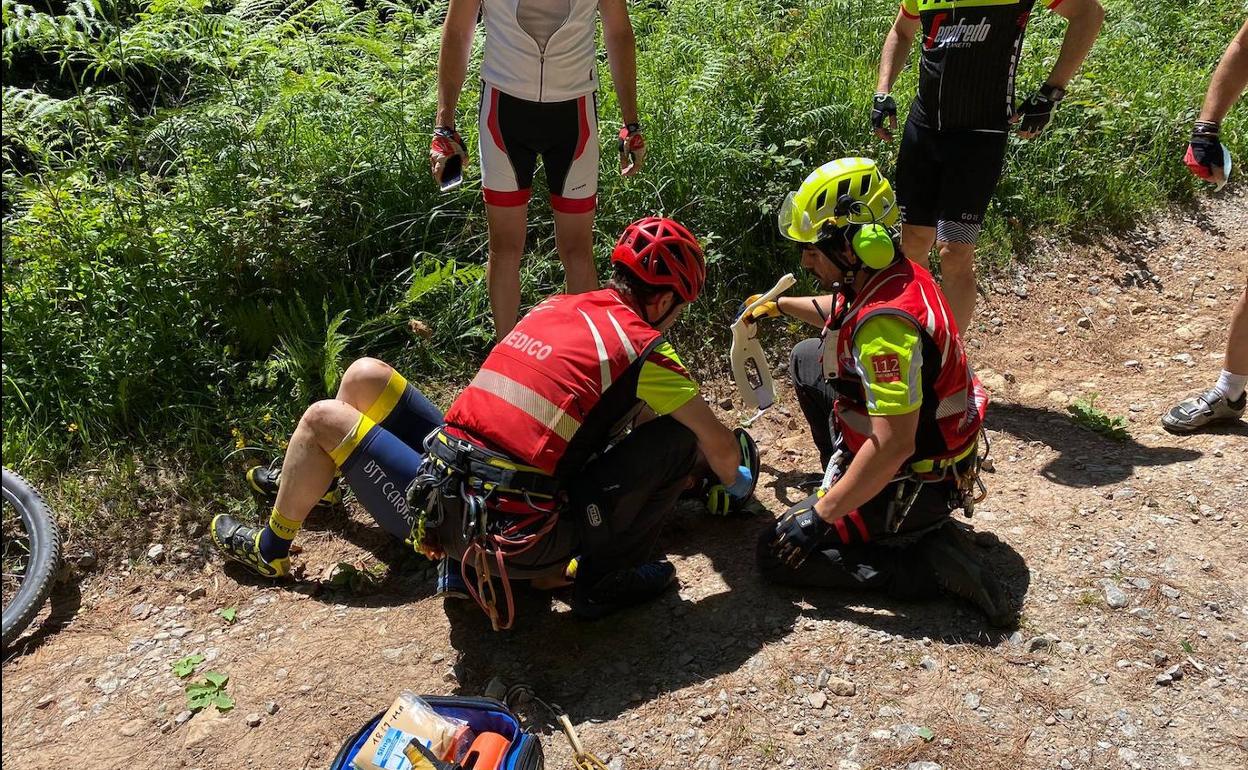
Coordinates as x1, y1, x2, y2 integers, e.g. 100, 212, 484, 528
2, 0, 1248, 486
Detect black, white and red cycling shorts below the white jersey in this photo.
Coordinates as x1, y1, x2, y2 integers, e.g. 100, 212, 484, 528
479, 84, 598, 213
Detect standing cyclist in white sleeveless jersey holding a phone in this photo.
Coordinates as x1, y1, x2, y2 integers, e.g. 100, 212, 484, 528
429, 0, 645, 338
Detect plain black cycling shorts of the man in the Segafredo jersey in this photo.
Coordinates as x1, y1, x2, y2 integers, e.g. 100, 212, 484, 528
897, 112, 1007, 243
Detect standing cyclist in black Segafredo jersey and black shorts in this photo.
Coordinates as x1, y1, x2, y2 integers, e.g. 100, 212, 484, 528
871, 0, 1104, 331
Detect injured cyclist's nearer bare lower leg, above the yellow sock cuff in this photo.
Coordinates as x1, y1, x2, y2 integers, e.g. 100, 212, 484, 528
275, 398, 361, 522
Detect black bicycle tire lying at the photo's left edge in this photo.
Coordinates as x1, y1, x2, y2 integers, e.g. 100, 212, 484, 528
2, 468, 61, 646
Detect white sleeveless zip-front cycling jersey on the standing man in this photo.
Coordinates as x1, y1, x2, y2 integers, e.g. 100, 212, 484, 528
480, 0, 598, 101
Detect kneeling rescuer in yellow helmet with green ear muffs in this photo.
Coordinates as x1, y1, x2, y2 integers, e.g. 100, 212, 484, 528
751, 158, 1013, 625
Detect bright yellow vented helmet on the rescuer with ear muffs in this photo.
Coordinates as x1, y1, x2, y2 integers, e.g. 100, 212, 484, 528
779, 157, 900, 243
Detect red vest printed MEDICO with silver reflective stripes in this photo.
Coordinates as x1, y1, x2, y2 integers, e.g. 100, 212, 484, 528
446, 288, 661, 474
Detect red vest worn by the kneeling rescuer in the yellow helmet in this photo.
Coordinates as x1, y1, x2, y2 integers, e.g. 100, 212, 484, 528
835, 258, 988, 461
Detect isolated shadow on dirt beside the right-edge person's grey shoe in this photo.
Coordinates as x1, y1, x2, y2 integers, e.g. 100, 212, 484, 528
986, 403, 1201, 488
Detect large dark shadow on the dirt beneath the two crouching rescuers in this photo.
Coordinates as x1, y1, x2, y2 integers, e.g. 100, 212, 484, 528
447, 504, 1030, 721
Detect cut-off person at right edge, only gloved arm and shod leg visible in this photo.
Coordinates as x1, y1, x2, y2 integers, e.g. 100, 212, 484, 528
1162, 21, 1248, 433
